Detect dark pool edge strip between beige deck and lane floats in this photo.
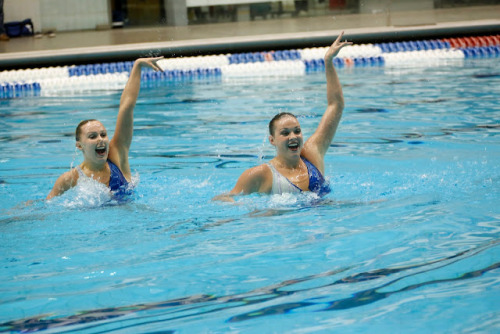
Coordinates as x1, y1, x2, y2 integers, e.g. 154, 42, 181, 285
0, 20, 500, 69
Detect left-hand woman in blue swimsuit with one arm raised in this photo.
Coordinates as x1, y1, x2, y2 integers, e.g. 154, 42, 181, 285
46, 57, 163, 200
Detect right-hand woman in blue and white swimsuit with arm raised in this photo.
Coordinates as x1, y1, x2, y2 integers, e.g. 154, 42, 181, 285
214, 32, 352, 201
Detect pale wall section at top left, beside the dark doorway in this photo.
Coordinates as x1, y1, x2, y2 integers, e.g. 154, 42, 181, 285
4, 0, 111, 31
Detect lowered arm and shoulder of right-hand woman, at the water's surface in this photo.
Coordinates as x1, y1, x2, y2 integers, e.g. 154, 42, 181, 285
213, 165, 273, 202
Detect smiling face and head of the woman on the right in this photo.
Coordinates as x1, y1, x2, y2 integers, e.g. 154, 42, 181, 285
269, 116, 304, 156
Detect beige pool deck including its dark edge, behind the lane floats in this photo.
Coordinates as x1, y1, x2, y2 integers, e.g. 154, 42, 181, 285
0, 5, 500, 70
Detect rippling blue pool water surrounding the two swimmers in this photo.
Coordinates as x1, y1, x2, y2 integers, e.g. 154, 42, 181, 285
0, 59, 500, 333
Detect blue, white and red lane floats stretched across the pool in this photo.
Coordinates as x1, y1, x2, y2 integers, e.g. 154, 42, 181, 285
0, 35, 500, 98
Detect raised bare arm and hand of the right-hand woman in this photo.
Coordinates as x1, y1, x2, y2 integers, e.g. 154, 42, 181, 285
304, 32, 352, 173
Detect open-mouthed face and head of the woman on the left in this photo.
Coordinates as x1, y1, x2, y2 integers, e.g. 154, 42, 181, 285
76, 121, 109, 161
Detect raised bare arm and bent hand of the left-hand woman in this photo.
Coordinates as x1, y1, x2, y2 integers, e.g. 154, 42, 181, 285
109, 57, 163, 174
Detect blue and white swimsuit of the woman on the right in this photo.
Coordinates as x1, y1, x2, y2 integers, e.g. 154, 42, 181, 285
268, 157, 330, 196
